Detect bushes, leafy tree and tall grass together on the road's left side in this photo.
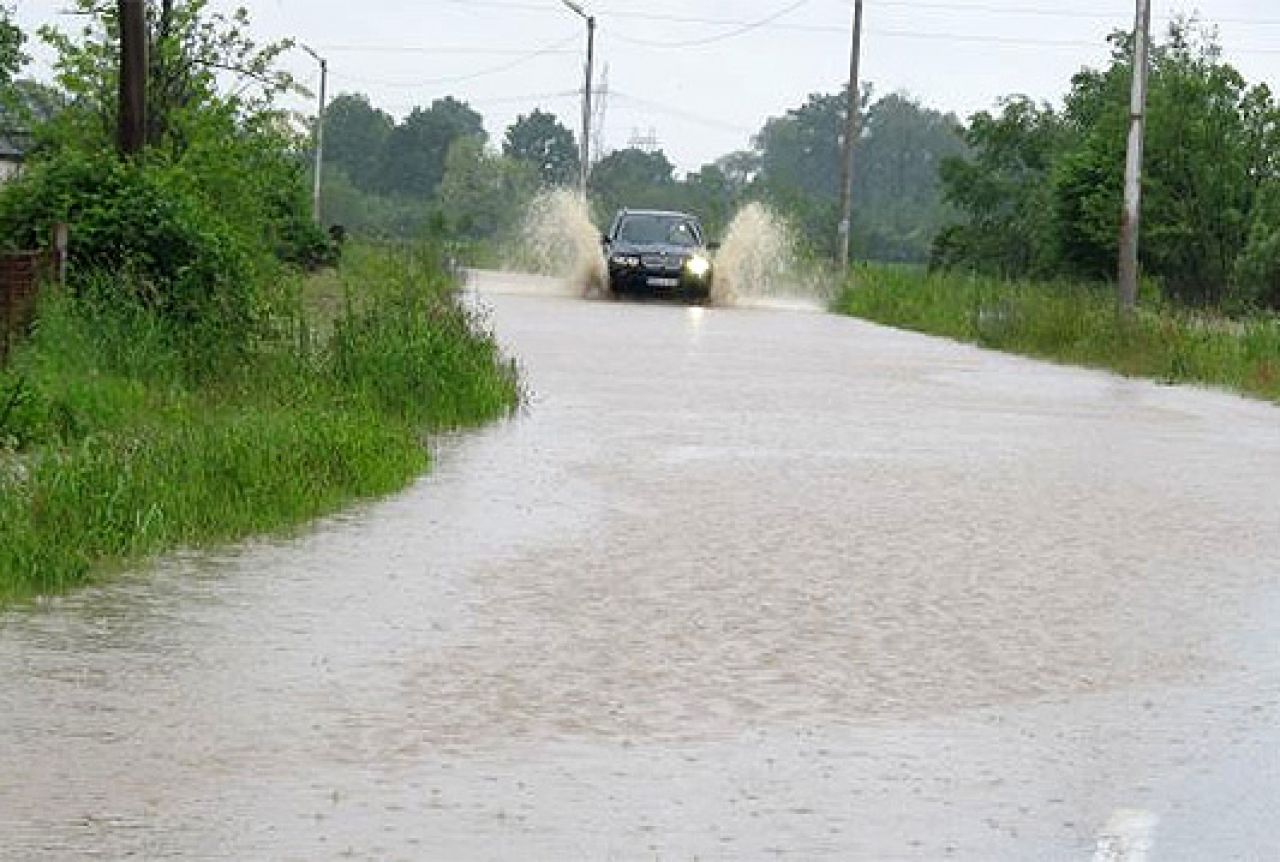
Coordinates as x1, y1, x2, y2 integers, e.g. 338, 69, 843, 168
0, 0, 520, 605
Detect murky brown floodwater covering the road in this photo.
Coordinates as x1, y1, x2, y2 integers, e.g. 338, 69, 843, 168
0, 275, 1280, 861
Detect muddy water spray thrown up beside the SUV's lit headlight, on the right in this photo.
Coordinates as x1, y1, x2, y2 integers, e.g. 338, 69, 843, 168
712, 204, 796, 305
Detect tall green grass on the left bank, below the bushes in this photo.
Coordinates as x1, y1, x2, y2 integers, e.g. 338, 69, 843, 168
0, 240, 518, 605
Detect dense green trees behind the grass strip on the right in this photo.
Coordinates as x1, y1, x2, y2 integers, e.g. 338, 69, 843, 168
934, 23, 1280, 307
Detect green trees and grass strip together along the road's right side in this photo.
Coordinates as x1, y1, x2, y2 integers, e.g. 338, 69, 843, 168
836, 22, 1280, 401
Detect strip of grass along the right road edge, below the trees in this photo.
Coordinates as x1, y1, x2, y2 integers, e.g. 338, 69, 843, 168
835, 266, 1280, 402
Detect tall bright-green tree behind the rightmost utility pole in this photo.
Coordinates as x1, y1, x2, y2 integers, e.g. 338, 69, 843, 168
1055, 22, 1276, 305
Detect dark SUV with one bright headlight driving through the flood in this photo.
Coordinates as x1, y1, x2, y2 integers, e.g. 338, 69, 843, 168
604, 210, 717, 300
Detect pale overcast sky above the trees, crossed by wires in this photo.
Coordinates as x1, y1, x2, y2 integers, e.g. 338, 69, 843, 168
17, 0, 1280, 170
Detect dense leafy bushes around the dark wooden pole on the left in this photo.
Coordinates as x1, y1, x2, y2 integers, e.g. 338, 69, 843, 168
0, 0, 332, 330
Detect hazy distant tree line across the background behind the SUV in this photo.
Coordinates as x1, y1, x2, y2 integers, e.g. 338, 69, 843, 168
325, 91, 965, 261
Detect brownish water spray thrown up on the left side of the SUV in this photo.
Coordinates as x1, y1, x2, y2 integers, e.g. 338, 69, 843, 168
509, 188, 607, 297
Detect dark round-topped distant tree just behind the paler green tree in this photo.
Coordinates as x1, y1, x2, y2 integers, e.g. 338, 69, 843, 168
380, 96, 488, 197
